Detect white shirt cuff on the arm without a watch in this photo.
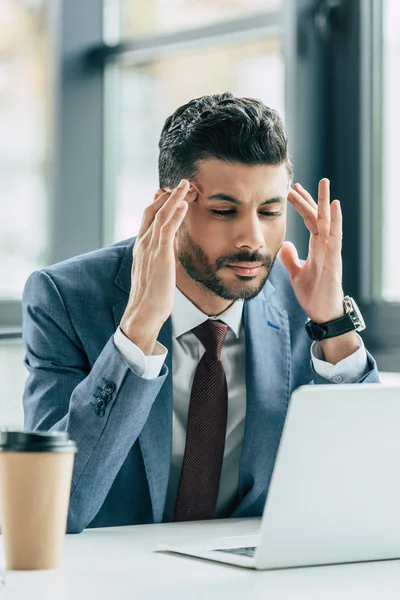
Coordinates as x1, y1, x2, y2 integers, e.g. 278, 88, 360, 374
114, 327, 168, 379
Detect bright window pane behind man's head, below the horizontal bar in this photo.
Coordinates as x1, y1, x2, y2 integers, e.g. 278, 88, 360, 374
113, 38, 284, 241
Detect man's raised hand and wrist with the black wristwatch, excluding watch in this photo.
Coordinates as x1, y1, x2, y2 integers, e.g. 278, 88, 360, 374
280, 179, 358, 364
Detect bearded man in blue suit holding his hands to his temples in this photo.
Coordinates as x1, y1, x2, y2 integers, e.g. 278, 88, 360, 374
23, 93, 378, 532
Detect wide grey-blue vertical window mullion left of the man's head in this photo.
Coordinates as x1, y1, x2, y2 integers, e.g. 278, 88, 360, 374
49, 0, 104, 262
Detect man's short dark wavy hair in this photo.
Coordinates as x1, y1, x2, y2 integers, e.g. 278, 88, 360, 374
158, 92, 293, 188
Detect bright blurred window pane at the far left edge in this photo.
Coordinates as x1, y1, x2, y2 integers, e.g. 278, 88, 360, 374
0, 0, 51, 301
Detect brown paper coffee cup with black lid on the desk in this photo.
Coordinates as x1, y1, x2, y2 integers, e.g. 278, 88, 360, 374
0, 431, 77, 570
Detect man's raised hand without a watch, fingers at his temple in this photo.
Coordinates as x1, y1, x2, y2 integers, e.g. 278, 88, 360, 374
120, 179, 194, 356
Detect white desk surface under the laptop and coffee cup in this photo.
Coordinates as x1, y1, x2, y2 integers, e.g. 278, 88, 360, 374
0, 519, 400, 600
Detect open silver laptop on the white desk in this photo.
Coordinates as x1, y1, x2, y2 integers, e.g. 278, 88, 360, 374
160, 384, 400, 570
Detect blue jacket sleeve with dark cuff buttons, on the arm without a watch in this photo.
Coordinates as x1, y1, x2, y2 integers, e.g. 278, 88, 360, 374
23, 271, 168, 533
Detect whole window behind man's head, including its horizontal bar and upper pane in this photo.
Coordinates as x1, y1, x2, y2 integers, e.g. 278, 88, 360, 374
105, 0, 285, 243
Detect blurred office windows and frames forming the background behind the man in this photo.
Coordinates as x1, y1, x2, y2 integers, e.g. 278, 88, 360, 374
0, 0, 400, 371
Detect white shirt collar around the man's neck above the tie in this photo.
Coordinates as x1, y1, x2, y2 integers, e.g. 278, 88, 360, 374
171, 288, 244, 338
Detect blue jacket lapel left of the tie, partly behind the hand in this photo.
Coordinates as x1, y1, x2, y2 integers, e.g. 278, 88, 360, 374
113, 241, 172, 523
